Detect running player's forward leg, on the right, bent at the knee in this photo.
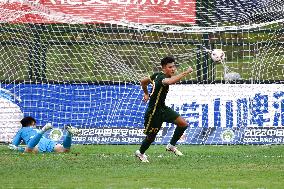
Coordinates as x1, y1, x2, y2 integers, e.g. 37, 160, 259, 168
165, 107, 188, 156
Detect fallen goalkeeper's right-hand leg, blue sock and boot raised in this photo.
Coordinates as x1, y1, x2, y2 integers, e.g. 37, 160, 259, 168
54, 126, 80, 153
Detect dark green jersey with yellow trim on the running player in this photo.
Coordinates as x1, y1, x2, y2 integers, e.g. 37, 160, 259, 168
148, 72, 169, 109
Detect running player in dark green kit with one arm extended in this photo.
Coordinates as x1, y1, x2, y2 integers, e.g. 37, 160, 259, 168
135, 56, 193, 162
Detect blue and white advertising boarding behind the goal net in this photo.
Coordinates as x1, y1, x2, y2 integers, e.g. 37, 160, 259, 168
1, 84, 284, 144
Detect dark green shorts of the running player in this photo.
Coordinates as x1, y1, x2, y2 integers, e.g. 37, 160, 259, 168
144, 106, 180, 135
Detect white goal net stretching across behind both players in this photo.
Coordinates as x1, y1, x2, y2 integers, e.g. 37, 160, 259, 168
0, 0, 284, 144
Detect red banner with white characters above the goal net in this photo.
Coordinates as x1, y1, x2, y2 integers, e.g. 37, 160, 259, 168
0, 0, 196, 24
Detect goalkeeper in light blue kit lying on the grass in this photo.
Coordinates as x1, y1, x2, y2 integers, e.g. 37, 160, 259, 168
9, 117, 79, 153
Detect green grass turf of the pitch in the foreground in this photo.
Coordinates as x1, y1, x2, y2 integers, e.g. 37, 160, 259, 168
0, 145, 284, 189
